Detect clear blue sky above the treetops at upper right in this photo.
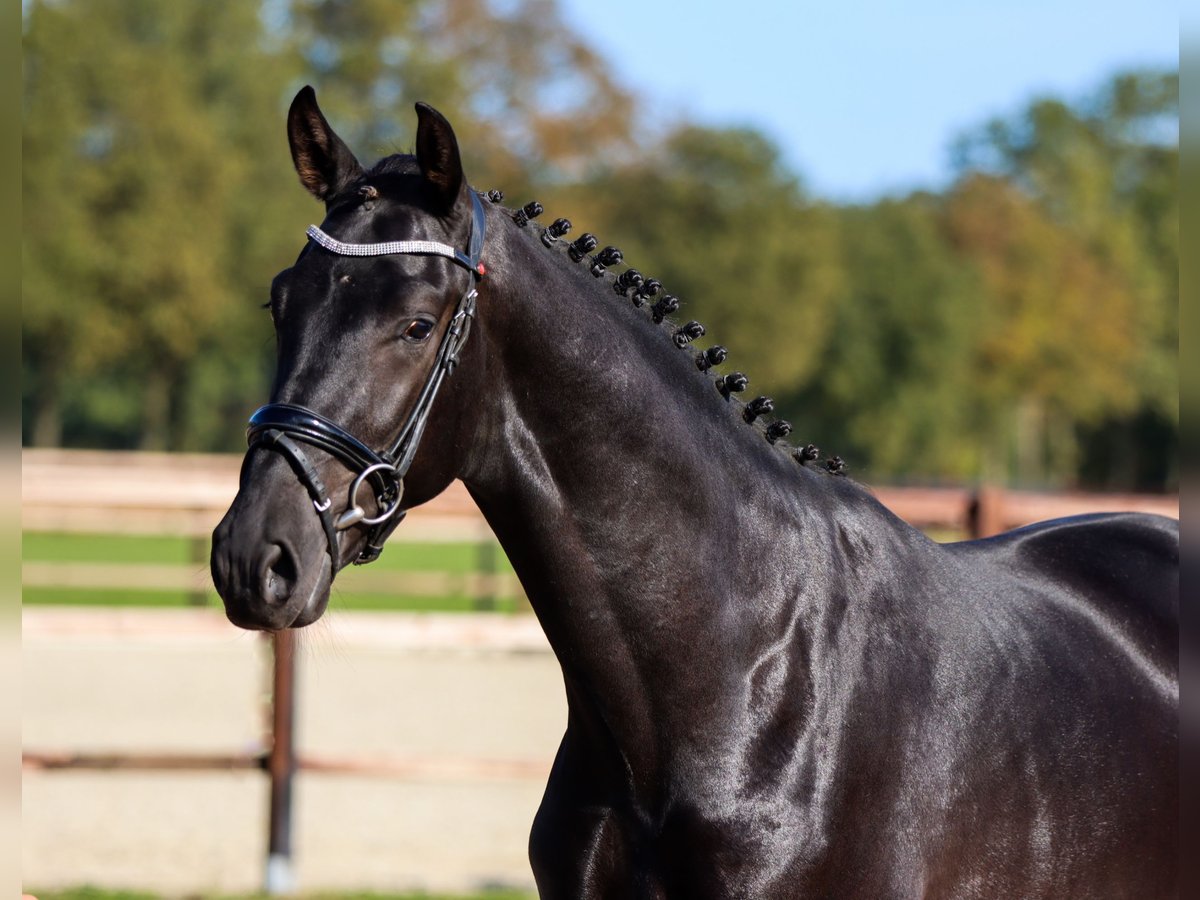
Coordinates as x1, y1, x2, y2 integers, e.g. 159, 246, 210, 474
563, 0, 1180, 200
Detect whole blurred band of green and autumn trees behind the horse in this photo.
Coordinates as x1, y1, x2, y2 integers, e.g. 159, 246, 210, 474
23, 0, 1178, 487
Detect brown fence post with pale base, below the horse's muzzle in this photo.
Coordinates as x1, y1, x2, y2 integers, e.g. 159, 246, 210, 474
265, 629, 296, 895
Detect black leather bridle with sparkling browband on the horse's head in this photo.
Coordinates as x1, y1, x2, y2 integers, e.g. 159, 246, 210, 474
246, 191, 486, 572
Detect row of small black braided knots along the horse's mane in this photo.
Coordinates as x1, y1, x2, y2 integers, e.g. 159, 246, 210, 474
481, 190, 847, 476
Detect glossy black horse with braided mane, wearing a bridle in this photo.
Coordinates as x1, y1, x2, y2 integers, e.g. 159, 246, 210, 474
212, 88, 1178, 900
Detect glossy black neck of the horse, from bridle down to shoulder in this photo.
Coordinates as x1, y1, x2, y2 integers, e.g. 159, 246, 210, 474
461, 222, 888, 777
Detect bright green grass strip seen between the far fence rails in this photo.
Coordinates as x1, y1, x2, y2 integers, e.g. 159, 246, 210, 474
22, 532, 522, 612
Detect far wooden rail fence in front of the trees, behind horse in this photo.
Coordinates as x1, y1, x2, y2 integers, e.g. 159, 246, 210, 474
22, 450, 1180, 608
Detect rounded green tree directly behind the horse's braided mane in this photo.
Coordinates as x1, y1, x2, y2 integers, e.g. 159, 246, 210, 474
571, 126, 841, 400
